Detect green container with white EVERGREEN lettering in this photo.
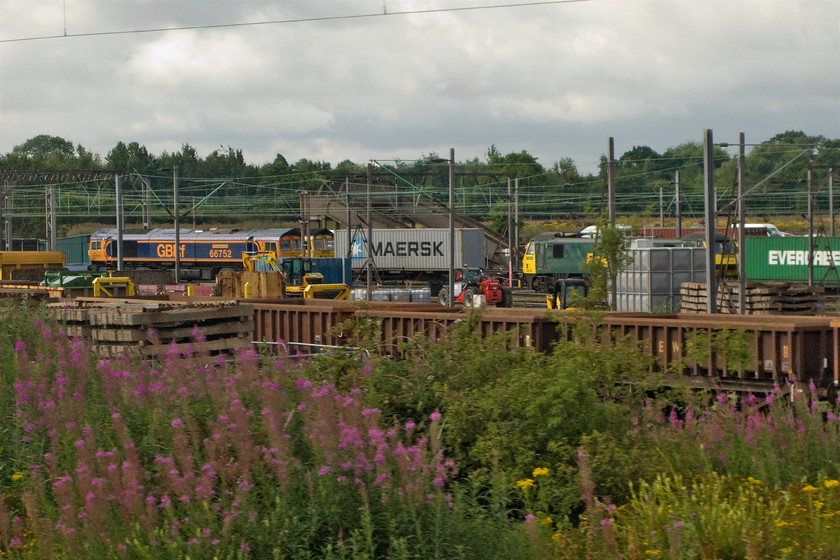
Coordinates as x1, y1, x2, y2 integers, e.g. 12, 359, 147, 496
744, 237, 840, 285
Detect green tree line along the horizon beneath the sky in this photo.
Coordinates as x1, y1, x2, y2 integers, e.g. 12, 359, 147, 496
0, 131, 840, 234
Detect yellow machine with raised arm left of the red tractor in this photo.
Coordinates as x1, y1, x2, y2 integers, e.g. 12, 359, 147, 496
242, 251, 350, 299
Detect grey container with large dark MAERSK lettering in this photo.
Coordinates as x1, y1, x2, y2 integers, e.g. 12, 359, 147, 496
335, 228, 482, 272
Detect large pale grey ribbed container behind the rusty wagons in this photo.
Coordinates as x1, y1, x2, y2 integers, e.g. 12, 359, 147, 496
616, 247, 706, 313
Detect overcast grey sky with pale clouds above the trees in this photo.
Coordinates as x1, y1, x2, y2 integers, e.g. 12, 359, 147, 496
0, 0, 840, 172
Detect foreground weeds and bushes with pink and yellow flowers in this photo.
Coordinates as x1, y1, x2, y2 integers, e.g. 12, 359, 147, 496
0, 305, 840, 560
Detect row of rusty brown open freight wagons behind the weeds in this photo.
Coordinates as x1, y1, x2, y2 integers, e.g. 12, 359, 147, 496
253, 302, 840, 395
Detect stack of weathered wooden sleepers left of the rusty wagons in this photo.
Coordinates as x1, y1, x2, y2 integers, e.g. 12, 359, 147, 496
47, 298, 254, 356
